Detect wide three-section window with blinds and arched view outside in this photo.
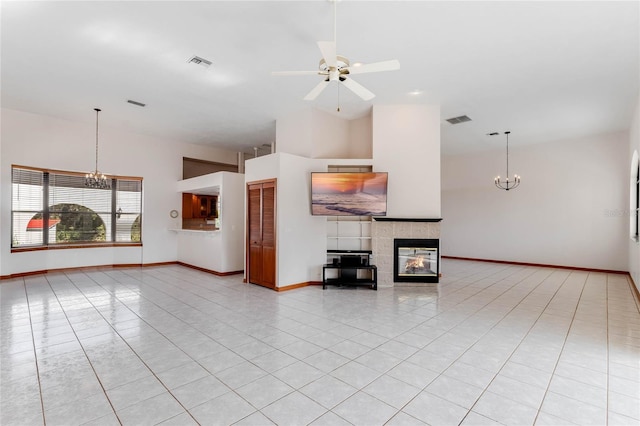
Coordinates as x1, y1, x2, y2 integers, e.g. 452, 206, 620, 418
11, 166, 142, 249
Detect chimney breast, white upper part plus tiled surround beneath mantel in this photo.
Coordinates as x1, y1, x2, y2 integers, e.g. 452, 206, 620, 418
372, 105, 441, 287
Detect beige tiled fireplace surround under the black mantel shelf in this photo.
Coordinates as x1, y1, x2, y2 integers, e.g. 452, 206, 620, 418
371, 219, 440, 287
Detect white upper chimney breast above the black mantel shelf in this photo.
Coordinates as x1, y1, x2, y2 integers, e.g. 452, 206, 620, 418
372, 105, 441, 218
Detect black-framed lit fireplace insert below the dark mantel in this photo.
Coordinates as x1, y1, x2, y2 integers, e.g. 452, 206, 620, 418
393, 238, 440, 283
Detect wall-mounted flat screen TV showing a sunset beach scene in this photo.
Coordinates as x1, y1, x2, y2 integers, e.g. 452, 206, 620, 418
311, 172, 387, 216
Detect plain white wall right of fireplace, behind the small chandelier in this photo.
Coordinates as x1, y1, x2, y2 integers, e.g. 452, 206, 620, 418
441, 133, 629, 271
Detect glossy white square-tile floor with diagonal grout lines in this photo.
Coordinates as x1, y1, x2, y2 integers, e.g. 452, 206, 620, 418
0, 259, 640, 426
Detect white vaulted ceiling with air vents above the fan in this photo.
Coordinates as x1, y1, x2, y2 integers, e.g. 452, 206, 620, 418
1, 0, 640, 155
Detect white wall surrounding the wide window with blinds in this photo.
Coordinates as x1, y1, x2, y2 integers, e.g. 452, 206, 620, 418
0, 109, 237, 276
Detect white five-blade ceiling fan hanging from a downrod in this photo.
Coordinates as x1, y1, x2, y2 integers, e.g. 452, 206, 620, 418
272, 0, 400, 101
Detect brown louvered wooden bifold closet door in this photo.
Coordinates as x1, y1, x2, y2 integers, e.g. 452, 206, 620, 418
247, 180, 276, 288
